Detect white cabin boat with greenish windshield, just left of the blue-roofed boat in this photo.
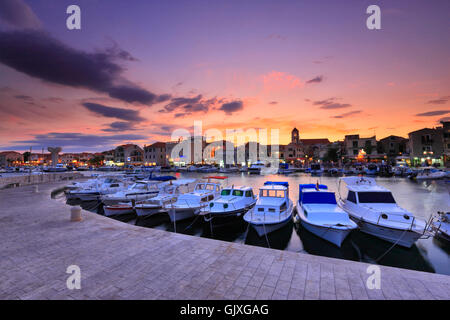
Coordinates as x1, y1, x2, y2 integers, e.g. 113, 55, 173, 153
204, 186, 256, 227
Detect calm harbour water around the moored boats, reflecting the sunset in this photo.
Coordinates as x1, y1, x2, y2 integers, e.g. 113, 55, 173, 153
67, 173, 450, 275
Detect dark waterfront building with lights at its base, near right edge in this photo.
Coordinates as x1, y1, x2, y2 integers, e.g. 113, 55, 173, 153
408, 127, 444, 166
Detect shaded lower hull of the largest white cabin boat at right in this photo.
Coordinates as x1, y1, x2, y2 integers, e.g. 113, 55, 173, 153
350, 215, 421, 248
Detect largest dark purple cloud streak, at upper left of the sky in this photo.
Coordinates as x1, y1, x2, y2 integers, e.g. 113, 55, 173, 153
0, 30, 169, 105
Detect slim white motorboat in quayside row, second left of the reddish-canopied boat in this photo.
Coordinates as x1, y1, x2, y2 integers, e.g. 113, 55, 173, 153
100, 181, 166, 206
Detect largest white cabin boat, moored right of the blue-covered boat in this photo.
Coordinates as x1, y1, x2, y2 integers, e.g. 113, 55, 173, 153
339, 177, 427, 248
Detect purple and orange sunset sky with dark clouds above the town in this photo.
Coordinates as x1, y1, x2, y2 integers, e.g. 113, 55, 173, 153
0, 0, 450, 152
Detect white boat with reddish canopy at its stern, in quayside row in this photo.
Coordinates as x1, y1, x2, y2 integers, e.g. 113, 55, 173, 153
164, 176, 227, 222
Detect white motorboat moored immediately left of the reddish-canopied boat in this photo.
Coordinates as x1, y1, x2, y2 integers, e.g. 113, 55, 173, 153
134, 179, 196, 217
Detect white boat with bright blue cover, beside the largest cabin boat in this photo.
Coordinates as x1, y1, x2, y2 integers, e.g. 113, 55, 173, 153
297, 183, 358, 247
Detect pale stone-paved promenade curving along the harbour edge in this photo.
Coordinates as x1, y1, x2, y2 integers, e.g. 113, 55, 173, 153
0, 183, 450, 299
